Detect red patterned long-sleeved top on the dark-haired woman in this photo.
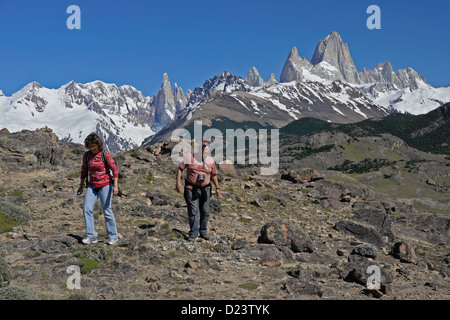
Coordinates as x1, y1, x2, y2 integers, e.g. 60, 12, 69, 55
81, 152, 119, 188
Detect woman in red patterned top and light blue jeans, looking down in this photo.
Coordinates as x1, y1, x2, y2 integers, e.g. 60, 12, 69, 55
78, 133, 119, 245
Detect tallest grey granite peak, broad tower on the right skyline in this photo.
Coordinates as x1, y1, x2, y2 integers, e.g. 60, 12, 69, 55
311, 31, 360, 83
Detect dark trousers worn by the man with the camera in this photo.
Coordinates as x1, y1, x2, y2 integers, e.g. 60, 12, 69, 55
184, 188, 211, 237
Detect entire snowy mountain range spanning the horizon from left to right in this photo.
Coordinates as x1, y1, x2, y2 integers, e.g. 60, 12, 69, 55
0, 31, 450, 152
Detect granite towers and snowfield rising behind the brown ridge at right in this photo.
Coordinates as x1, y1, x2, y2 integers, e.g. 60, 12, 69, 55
280, 31, 450, 114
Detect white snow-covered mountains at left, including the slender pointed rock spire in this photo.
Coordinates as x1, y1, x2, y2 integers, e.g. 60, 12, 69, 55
0, 75, 186, 152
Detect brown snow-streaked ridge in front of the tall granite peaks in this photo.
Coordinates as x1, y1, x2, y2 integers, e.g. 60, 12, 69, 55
144, 68, 391, 144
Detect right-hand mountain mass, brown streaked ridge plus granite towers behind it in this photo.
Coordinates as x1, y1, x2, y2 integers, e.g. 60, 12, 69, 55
146, 31, 450, 143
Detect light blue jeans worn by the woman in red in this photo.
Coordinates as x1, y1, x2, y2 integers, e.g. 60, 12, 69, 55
83, 185, 118, 240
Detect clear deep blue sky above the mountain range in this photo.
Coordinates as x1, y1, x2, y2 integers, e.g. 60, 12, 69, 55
0, 0, 450, 96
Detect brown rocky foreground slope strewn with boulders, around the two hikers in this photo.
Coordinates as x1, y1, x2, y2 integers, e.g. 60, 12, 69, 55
0, 129, 450, 300
